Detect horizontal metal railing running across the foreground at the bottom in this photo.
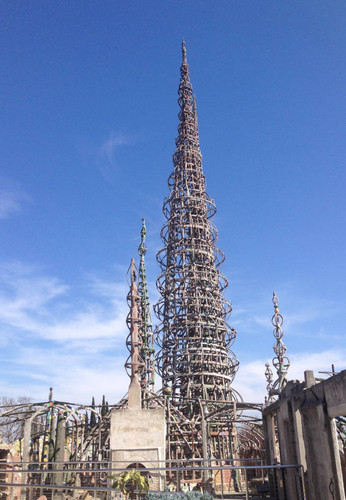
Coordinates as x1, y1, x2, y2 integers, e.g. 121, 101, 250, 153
2, 459, 306, 500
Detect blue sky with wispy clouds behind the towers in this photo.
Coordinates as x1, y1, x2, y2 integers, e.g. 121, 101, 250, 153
0, 0, 346, 403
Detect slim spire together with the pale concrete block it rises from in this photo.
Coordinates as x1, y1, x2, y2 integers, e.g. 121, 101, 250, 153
110, 259, 166, 490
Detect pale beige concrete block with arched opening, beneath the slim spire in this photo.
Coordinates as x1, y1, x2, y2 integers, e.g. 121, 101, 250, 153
110, 408, 166, 490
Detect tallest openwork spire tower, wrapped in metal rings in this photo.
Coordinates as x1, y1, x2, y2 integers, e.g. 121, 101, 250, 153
155, 42, 238, 456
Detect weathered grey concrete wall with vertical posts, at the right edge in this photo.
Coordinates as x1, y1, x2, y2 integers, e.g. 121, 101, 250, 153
263, 370, 346, 500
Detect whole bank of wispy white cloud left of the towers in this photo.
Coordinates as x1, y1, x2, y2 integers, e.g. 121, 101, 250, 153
0, 262, 128, 402
